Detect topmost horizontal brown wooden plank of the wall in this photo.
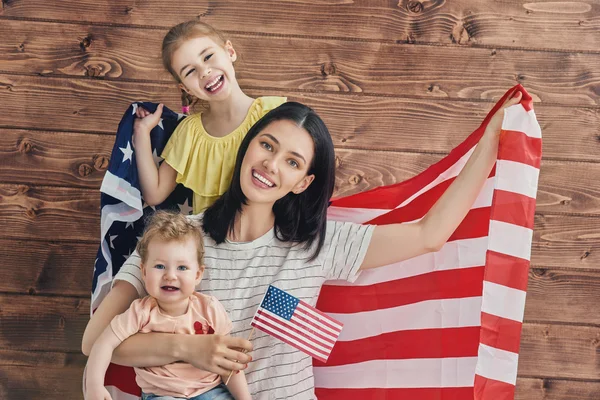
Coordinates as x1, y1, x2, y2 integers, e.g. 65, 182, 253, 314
0, 0, 600, 51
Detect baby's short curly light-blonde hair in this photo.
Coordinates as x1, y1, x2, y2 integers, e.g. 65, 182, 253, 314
137, 210, 204, 267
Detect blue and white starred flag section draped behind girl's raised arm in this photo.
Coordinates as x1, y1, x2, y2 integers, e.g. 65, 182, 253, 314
91, 103, 192, 311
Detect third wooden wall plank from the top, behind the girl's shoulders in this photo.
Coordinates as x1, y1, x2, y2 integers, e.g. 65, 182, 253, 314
0, 74, 600, 162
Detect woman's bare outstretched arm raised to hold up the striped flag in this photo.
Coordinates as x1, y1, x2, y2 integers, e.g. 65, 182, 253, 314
360, 92, 521, 270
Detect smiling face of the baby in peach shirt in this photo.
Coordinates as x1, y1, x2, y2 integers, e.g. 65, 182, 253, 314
143, 238, 204, 303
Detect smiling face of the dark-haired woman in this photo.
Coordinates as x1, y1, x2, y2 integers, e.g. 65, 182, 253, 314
240, 120, 315, 204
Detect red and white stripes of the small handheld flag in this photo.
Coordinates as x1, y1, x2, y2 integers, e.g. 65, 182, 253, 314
251, 300, 342, 362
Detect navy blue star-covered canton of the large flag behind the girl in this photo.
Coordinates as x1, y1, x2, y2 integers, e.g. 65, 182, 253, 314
92, 102, 192, 300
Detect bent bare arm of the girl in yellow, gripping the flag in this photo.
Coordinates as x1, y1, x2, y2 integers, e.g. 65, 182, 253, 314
133, 104, 177, 206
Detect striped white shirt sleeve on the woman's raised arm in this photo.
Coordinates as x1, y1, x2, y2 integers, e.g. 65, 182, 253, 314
322, 221, 375, 282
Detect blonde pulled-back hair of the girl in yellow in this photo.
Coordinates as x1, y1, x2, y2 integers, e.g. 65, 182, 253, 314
162, 20, 227, 113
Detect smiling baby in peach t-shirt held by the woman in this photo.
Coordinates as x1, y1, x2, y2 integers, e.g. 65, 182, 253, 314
85, 211, 250, 400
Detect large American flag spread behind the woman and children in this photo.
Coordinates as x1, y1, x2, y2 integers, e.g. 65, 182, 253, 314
92, 85, 541, 400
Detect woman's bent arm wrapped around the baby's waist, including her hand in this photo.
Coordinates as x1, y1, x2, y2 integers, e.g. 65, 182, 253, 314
82, 281, 252, 375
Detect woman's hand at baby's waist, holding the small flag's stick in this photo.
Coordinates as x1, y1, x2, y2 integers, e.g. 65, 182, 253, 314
182, 335, 252, 375
